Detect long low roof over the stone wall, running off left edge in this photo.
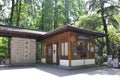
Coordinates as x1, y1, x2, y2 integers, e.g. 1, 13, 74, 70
0, 25, 47, 38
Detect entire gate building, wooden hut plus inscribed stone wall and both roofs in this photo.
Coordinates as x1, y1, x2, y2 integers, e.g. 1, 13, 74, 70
0, 25, 106, 67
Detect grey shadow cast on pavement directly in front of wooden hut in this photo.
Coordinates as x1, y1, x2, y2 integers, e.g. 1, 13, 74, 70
37, 65, 120, 77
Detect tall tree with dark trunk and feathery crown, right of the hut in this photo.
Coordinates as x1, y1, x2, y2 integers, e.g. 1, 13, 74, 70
87, 0, 119, 55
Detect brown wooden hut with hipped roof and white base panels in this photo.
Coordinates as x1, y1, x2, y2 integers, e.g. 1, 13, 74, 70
41, 25, 106, 67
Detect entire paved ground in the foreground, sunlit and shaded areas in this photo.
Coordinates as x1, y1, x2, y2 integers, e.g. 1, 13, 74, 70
0, 65, 120, 82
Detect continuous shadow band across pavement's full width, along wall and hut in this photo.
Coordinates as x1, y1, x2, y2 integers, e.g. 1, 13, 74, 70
0, 64, 120, 77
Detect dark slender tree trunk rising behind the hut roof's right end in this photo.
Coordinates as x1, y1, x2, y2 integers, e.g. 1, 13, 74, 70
100, 0, 110, 55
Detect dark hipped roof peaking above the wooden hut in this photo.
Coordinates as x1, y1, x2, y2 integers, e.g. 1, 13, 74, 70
44, 25, 107, 38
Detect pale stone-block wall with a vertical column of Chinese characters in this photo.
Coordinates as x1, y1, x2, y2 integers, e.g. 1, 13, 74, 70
10, 37, 36, 65
